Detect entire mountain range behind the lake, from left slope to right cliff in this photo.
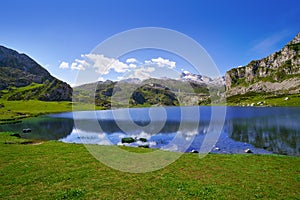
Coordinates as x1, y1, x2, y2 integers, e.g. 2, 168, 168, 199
0, 33, 300, 108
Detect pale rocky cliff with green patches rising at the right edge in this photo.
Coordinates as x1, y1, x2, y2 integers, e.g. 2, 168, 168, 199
225, 33, 300, 96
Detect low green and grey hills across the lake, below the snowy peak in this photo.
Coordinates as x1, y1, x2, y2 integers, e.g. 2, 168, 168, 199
73, 74, 223, 109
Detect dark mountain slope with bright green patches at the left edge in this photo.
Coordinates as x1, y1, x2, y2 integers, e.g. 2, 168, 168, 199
0, 46, 72, 101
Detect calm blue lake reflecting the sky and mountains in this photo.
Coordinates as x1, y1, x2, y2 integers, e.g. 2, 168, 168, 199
0, 106, 300, 156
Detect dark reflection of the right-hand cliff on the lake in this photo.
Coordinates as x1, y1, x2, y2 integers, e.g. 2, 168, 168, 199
227, 113, 300, 156
